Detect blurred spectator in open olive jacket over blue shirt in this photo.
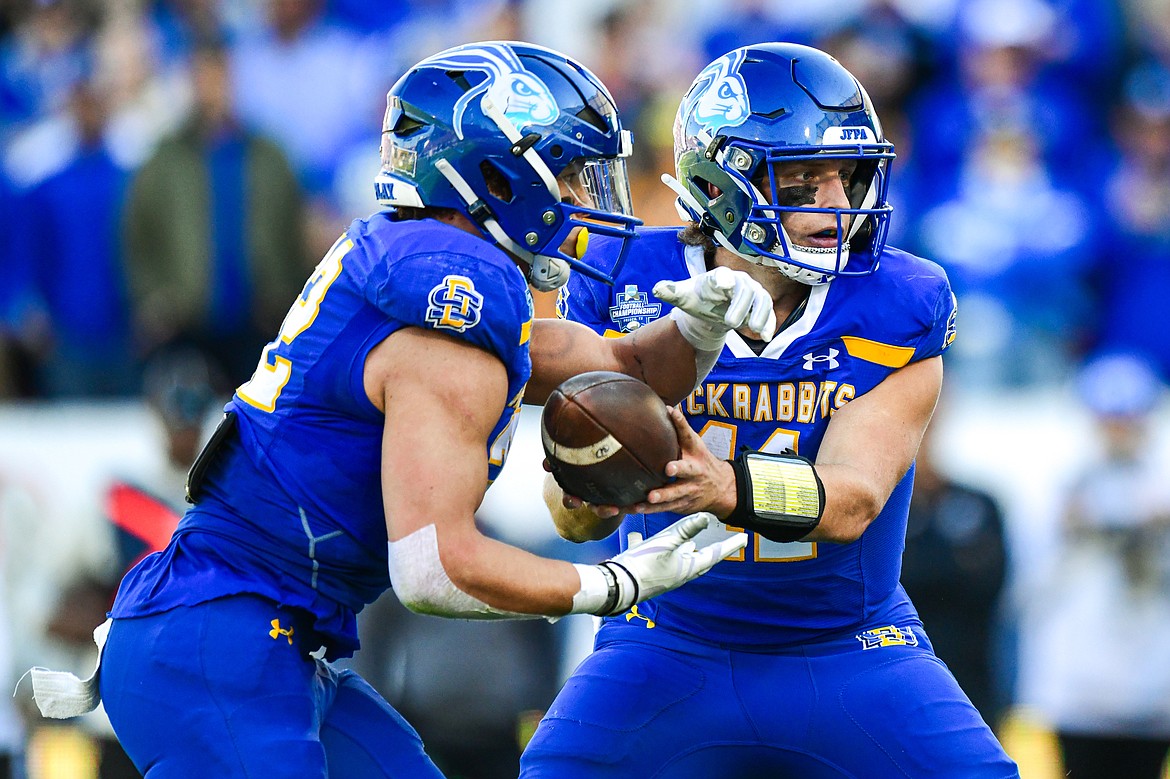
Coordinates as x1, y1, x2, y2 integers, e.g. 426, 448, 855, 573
125, 38, 307, 386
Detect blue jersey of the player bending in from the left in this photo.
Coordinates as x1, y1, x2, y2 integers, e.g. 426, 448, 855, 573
112, 214, 534, 656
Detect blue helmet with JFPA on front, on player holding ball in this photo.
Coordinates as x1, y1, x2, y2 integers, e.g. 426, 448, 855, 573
662, 43, 894, 284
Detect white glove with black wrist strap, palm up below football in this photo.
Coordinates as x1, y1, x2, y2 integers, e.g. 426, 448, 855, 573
571, 511, 748, 616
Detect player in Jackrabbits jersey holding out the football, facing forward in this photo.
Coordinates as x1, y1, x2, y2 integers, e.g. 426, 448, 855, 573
521, 43, 1018, 779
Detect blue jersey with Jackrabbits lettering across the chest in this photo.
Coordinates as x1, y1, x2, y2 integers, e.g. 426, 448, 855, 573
558, 228, 956, 649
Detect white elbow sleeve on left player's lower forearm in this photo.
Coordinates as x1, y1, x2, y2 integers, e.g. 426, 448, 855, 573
387, 524, 541, 620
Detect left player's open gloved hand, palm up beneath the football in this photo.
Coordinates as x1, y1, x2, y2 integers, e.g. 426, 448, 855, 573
601, 511, 748, 614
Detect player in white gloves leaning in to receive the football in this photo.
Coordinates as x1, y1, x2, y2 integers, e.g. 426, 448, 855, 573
25, 43, 775, 779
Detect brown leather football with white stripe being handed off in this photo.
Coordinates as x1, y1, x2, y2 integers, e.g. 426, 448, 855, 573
541, 371, 680, 505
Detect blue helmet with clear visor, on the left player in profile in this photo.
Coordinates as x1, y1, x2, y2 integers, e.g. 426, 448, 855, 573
374, 41, 641, 291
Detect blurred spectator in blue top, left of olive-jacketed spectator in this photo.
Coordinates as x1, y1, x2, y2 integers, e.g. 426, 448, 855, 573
18, 81, 138, 398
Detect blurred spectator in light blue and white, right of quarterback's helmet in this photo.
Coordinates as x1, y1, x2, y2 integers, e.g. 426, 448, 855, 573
918, 126, 1096, 388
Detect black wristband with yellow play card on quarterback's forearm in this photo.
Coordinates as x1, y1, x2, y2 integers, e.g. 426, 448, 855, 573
724, 451, 825, 542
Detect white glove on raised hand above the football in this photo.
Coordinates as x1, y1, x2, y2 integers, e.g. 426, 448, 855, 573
654, 266, 776, 351
